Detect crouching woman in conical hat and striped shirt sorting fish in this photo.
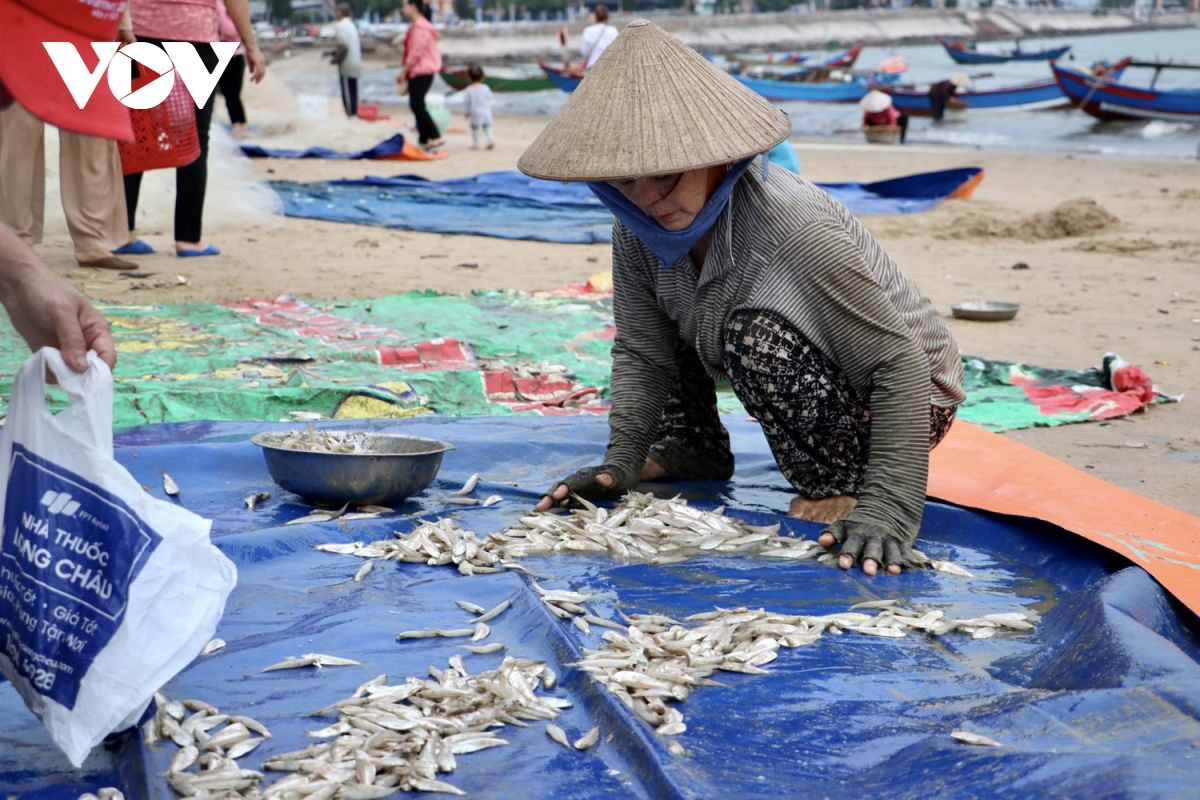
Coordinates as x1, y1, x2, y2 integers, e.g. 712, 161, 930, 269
517, 20, 964, 575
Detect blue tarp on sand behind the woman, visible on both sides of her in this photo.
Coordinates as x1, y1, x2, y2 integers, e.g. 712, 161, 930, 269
271, 167, 979, 245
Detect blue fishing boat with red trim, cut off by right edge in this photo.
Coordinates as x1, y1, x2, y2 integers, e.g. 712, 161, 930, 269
1050, 60, 1200, 122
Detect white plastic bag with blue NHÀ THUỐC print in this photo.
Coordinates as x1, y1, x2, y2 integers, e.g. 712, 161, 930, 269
0, 348, 236, 766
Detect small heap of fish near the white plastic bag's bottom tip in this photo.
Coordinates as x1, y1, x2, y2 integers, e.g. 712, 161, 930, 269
142, 692, 271, 798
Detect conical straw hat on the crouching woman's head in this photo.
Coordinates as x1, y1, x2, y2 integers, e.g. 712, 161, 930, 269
517, 19, 792, 181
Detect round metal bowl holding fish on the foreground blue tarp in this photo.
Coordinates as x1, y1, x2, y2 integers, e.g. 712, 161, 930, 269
250, 431, 455, 505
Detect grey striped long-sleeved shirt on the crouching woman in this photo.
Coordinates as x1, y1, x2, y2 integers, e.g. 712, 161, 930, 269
605, 162, 965, 542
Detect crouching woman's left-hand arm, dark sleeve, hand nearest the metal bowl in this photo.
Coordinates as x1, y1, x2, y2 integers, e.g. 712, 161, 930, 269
538, 224, 679, 510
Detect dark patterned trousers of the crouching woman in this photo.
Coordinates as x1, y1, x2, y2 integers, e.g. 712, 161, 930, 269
649, 311, 958, 499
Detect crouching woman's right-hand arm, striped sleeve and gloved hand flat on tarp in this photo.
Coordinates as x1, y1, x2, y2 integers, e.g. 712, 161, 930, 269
757, 222, 930, 567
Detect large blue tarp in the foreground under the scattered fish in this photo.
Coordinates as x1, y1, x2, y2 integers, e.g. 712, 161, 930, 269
0, 416, 1200, 800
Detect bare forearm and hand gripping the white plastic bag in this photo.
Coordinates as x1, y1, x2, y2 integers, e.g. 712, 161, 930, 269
0, 225, 116, 372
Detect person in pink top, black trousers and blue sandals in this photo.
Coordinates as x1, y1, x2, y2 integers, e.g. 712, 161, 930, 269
125, 0, 266, 258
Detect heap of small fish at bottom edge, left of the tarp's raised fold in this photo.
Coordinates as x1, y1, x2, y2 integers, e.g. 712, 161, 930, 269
263, 656, 578, 799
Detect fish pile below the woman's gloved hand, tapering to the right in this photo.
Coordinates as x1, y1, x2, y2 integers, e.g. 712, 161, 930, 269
572, 600, 1037, 754
